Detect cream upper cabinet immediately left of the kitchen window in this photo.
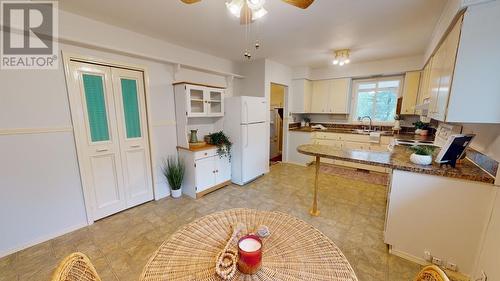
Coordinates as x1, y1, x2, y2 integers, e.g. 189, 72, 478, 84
311, 78, 351, 114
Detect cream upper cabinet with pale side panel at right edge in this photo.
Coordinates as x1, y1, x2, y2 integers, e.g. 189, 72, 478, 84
422, 1, 500, 123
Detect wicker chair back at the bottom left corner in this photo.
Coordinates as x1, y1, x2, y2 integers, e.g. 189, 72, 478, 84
52, 253, 101, 281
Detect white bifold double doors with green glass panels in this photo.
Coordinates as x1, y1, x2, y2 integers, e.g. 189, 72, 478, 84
68, 62, 153, 220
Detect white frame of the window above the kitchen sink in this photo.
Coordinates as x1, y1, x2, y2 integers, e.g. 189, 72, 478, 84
350, 75, 404, 126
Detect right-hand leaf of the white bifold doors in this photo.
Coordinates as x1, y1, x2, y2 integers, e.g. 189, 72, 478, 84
111, 68, 153, 207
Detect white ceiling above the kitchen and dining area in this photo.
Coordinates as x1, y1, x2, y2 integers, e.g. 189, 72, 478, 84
59, 0, 446, 68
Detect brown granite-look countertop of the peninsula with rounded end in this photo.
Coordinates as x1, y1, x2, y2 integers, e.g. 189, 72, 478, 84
297, 144, 495, 184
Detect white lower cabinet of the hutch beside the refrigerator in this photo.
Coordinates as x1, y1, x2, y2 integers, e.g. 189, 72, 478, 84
179, 148, 231, 198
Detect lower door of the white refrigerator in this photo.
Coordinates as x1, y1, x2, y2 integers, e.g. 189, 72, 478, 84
241, 122, 269, 183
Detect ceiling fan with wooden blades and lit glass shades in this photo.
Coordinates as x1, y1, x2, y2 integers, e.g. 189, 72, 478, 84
181, 0, 314, 24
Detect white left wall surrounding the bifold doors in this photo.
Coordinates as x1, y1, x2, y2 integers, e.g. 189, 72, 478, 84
0, 11, 234, 257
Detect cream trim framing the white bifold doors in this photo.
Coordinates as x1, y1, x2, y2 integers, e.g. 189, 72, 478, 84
61, 51, 159, 225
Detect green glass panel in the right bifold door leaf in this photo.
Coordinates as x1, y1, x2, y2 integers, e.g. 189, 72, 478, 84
121, 79, 141, 138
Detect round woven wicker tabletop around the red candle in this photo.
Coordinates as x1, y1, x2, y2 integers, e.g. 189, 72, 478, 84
140, 209, 357, 281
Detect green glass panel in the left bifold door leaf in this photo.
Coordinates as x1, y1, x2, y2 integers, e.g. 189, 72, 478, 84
83, 74, 109, 142
